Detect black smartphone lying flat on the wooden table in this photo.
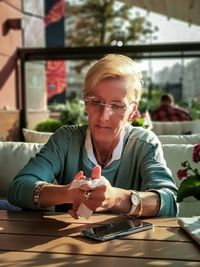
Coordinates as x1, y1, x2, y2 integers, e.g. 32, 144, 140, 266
81, 218, 153, 241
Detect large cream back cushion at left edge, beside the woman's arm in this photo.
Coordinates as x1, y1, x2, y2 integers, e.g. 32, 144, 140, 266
0, 142, 43, 198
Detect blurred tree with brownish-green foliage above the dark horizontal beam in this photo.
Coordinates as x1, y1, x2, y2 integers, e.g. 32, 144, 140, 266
65, 0, 158, 46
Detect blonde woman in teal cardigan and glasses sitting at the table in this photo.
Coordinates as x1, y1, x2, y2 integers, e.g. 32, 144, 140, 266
8, 54, 177, 218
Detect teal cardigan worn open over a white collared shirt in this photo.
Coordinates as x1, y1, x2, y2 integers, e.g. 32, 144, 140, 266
8, 125, 178, 216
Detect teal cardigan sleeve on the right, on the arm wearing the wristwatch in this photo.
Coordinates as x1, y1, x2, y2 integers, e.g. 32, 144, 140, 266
114, 127, 178, 216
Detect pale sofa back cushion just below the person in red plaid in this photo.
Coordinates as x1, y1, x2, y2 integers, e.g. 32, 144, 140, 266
158, 134, 200, 145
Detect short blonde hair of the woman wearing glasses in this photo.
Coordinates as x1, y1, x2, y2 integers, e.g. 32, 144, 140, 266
83, 54, 143, 102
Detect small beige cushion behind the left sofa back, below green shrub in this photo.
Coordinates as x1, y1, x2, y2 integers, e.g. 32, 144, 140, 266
22, 128, 52, 144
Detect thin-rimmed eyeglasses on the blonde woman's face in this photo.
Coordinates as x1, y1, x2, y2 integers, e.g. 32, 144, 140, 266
84, 96, 129, 115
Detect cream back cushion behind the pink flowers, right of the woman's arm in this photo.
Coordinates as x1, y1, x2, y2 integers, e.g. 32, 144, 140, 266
162, 144, 200, 217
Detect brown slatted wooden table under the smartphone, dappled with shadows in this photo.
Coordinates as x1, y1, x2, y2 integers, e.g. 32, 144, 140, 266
0, 211, 200, 267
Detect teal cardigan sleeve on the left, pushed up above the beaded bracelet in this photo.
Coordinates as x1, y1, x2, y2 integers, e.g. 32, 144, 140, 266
7, 126, 82, 209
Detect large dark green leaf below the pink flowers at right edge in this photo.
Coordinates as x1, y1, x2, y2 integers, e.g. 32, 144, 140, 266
177, 175, 200, 202
